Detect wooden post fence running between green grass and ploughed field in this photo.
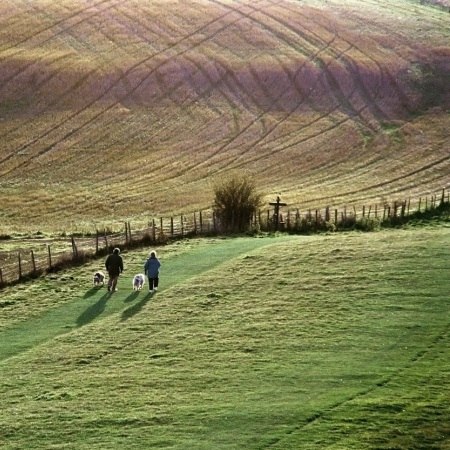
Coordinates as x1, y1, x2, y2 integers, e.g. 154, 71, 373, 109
0, 189, 450, 288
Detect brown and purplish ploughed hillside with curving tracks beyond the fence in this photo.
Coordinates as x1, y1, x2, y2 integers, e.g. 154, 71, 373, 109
0, 0, 450, 232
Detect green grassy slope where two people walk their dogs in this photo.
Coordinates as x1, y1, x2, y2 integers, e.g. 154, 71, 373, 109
0, 226, 450, 450
